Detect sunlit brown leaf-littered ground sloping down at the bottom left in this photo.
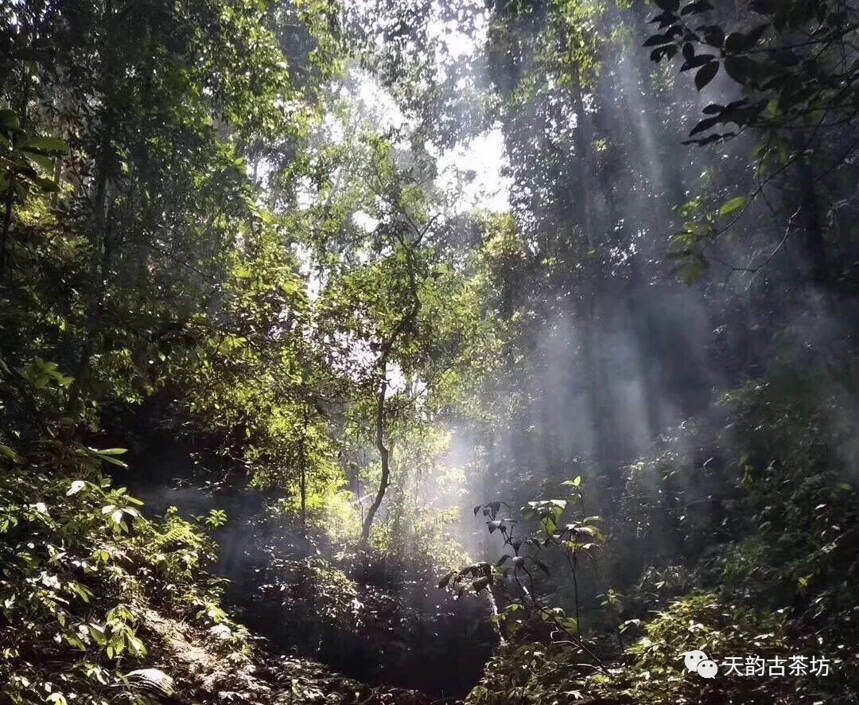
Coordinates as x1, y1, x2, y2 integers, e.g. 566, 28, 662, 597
143, 608, 445, 705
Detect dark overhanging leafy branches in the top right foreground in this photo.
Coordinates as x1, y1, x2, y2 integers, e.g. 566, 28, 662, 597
645, 0, 859, 286
